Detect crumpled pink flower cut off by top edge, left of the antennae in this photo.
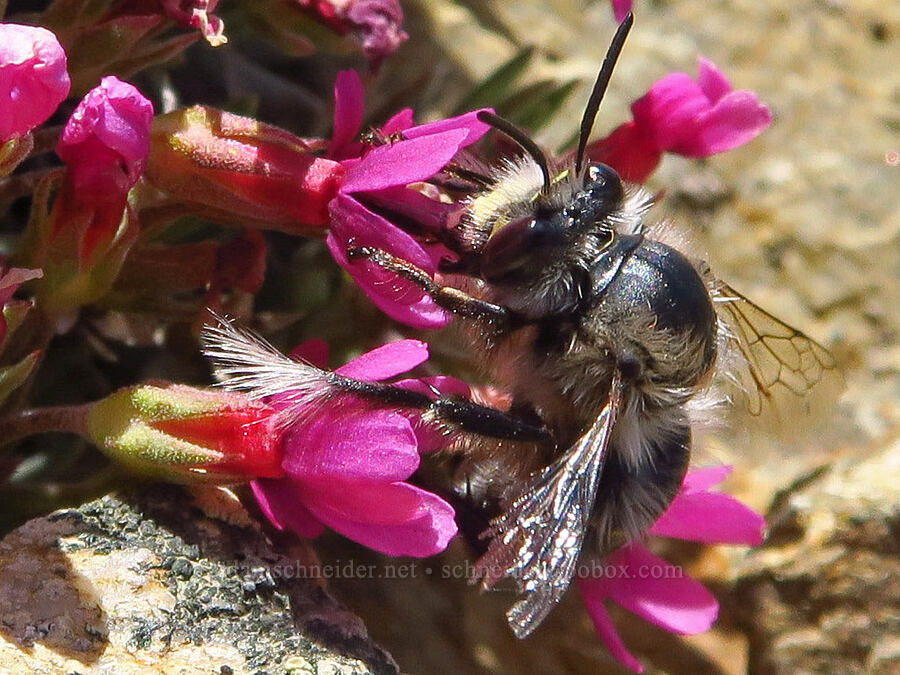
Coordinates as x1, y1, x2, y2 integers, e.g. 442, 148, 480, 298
296, 0, 409, 66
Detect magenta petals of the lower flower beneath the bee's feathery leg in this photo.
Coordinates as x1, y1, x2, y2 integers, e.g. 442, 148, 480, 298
251, 340, 464, 557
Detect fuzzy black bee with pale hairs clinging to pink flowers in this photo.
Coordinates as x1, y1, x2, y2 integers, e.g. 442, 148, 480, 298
206, 15, 835, 638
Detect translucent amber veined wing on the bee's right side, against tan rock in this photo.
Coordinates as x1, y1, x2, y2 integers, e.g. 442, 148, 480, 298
716, 283, 840, 415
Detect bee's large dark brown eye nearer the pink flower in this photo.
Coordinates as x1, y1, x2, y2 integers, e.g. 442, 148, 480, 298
481, 216, 565, 282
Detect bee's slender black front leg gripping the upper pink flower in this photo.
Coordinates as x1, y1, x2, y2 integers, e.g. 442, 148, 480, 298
347, 245, 519, 330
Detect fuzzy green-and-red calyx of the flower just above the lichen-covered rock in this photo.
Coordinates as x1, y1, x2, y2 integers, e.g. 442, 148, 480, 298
87, 384, 284, 483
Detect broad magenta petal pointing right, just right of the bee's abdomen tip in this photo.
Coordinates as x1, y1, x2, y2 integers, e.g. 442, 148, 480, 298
650, 492, 766, 546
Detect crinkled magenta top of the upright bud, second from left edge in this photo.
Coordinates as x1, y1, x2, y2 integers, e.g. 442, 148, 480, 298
56, 76, 153, 201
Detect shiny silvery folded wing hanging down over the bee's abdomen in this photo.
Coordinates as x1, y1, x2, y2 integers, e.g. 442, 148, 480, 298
476, 376, 622, 638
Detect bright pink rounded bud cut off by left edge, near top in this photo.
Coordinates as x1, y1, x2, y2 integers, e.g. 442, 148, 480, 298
0, 23, 70, 143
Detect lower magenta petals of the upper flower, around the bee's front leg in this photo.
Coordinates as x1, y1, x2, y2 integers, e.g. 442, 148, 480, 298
327, 194, 452, 328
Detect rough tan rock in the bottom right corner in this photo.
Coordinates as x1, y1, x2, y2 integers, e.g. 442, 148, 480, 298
735, 444, 900, 674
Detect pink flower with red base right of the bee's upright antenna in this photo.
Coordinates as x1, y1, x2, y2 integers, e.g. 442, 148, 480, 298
588, 58, 772, 182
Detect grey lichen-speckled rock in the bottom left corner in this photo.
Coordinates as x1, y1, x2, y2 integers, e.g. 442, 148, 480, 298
0, 485, 397, 675
